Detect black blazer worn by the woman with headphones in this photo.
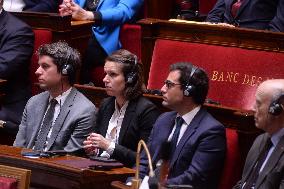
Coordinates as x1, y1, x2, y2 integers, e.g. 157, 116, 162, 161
95, 96, 160, 167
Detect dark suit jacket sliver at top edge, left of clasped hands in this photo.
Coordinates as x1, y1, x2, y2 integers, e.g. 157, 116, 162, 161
23, 0, 62, 12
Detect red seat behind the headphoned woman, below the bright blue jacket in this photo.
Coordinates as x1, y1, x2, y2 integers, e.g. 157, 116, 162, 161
91, 24, 141, 86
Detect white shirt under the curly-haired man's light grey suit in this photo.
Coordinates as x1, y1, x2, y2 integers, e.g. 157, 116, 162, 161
38, 87, 72, 151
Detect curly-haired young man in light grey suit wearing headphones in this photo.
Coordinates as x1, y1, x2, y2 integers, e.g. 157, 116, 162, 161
14, 42, 96, 152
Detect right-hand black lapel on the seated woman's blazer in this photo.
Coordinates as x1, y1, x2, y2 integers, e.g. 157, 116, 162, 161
118, 101, 137, 144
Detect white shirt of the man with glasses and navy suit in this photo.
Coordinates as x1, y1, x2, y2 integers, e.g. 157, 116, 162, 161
168, 106, 201, 145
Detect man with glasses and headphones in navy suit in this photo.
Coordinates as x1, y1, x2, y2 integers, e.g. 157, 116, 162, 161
140, 63, 226, 189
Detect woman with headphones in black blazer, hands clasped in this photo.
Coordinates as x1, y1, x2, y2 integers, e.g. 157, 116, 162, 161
84, 49, 160, 167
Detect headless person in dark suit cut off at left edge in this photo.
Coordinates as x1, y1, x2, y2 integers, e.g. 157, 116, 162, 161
0, 0, 34, 134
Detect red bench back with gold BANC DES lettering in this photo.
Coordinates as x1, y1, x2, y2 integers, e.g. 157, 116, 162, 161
147, 39, 284, 109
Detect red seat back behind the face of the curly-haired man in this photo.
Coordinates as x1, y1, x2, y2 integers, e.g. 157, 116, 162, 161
30, 29, 52, 95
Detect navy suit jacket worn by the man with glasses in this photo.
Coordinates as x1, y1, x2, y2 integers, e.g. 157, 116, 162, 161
140, 108, 226, 189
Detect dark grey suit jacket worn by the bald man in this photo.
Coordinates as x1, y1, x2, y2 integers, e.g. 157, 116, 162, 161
234, 133, 284, 189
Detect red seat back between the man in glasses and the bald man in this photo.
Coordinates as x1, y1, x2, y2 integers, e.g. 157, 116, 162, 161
219, 128, 242, 189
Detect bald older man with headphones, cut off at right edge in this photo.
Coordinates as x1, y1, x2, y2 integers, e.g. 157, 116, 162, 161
234, 79, 284, 189
